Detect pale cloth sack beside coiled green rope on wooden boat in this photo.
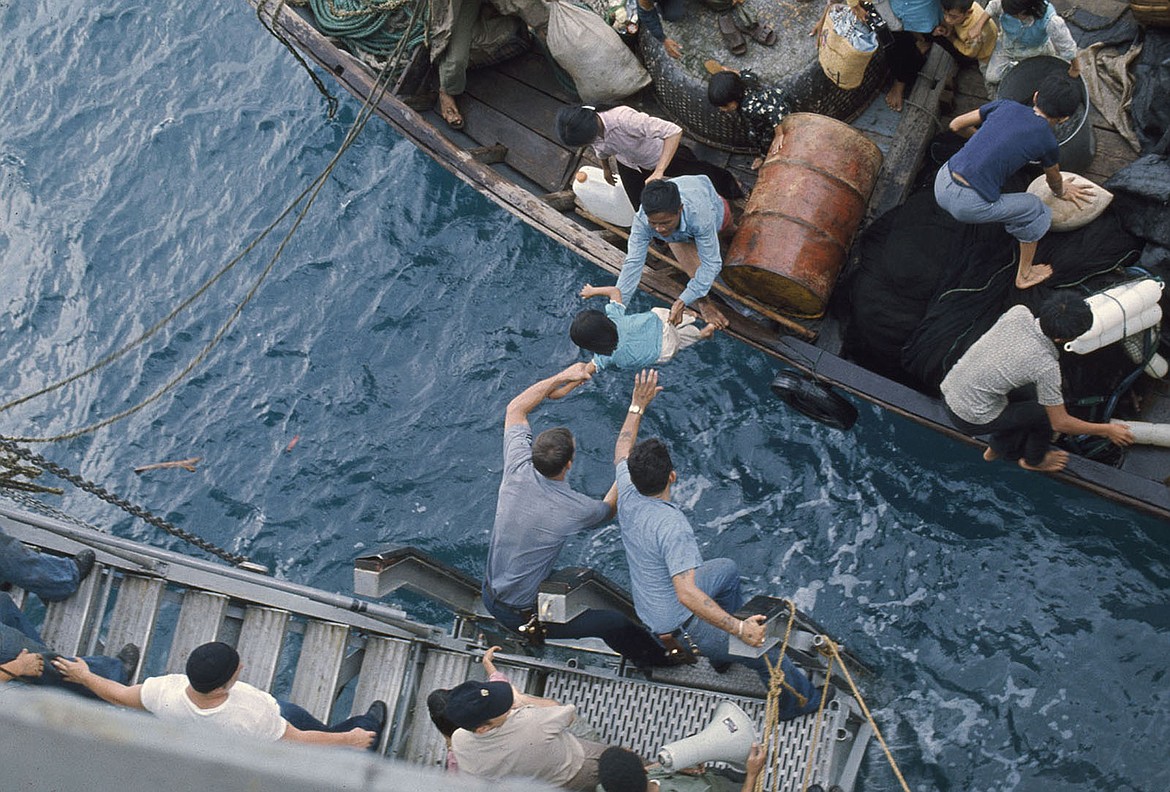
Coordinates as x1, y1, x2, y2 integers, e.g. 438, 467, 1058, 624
545, 0, 651, 104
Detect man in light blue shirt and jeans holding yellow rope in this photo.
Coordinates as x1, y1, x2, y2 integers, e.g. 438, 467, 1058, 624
613, 370, 821, 721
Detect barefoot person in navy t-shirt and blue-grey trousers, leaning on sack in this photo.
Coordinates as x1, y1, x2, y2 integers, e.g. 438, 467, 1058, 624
935, 75, 1090, 289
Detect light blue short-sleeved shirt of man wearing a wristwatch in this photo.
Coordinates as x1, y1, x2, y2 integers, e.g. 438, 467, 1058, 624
617, 460, 703, 634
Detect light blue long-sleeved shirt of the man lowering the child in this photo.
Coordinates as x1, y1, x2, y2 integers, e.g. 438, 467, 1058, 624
618, 175, 723, 305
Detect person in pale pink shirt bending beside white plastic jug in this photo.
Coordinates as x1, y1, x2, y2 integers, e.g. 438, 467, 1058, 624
557, 105, 743, 209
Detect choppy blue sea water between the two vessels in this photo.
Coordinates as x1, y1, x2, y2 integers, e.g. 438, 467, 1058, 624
0, 0, 1170, 792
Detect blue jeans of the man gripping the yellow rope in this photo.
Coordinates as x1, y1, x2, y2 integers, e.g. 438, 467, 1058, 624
686, 558, 820, 721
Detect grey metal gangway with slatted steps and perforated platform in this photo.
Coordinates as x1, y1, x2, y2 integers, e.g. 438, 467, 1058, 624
0, 496, 870, 792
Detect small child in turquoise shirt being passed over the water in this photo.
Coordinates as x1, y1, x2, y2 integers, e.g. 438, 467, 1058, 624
569, 283, 715, 373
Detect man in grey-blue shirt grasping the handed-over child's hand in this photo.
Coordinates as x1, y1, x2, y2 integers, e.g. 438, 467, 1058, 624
483, 363, 666, 668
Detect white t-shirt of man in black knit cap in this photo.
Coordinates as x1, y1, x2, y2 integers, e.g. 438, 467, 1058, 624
142, 674, 288, 741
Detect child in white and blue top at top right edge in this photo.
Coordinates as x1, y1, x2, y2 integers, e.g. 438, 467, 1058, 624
968, 0, 1081, 88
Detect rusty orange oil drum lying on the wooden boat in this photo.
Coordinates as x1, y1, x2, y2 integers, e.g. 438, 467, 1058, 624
723, 112, 882, 317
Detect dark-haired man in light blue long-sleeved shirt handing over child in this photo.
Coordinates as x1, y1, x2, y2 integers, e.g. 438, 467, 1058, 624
618, 175, 735, 330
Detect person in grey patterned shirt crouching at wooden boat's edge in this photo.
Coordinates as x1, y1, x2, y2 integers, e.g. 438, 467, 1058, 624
941, 291, 1134, 471
